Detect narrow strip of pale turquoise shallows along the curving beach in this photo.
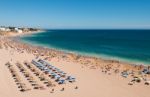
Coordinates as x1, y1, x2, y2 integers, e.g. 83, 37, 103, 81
14, 30, 150, 66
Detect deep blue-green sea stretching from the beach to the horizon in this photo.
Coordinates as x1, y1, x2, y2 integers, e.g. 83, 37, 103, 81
20, 29, 150, 65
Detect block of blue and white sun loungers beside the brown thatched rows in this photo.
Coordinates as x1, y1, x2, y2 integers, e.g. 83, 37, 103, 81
32, 59, 75, 84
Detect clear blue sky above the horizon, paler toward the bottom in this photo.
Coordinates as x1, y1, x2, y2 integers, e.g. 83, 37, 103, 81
0, 0, 150, 29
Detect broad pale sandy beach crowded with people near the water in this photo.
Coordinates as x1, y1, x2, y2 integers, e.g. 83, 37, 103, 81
0, 33, 150, 97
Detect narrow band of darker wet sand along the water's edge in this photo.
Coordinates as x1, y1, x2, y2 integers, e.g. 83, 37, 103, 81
9, 32, 149, 69
